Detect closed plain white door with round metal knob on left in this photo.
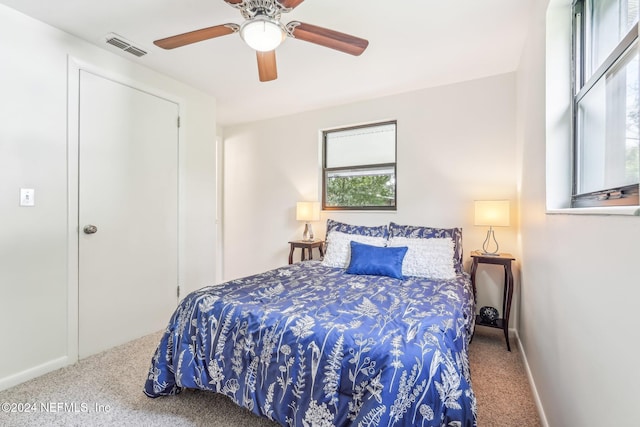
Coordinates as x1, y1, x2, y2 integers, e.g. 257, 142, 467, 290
78, 71, 178, 358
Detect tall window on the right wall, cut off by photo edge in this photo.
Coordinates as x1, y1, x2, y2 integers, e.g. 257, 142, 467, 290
571, 0, 640, 207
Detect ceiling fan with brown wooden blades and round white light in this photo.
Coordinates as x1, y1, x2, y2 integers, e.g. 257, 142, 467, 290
153, 0, 369, 82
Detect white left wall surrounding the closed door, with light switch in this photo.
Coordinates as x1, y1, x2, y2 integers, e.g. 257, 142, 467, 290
0, 5, 216, 389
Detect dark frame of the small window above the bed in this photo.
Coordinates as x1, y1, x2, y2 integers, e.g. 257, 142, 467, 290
322, 120, 398, 211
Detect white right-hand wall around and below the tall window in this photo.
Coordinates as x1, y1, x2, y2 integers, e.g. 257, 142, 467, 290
518, 0, 640, 427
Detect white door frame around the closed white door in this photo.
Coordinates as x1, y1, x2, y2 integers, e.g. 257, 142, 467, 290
67, 55, 186, 364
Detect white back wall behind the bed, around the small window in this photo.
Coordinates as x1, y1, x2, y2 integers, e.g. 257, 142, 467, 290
224, 73, 517, 324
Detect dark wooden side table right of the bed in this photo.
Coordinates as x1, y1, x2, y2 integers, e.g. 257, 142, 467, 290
471, 251, 515, 351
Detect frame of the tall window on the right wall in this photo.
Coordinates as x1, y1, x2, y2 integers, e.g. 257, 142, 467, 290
570, 0, 640, 208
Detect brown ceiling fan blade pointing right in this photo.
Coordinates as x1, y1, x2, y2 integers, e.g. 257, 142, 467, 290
287, 21, 369, 56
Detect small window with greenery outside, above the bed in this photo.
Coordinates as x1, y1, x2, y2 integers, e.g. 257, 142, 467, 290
322, 121, 396, 210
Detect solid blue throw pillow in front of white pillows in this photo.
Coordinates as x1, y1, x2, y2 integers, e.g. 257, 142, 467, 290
347, 241, 407, 280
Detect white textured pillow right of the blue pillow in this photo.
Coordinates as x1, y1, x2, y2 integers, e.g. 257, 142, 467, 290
388, 237, 456, 279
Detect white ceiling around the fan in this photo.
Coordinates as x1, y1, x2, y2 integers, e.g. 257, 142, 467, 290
0, 0, 536, 126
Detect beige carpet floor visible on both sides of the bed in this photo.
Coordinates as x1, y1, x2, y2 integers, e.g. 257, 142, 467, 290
0, 327, 540, 427
